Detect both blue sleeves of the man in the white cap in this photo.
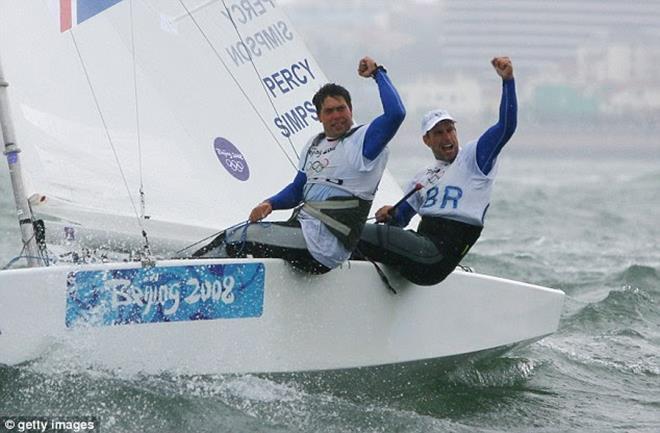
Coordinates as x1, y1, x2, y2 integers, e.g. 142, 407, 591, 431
391, 78, 518, 227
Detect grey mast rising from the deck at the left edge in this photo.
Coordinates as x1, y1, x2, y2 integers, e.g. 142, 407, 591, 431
0, 57, 42, 267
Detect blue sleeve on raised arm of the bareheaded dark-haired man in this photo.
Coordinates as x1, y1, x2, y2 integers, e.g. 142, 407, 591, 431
362, 69, 406, 160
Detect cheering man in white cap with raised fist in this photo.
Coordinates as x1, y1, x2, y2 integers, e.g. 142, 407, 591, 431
358, 57, 518, 285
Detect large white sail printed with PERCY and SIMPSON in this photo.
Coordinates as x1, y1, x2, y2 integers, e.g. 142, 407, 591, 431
0, 0, 400, 246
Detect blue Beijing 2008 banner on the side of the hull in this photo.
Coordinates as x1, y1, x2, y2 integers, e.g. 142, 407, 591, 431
66, 263, 265, 328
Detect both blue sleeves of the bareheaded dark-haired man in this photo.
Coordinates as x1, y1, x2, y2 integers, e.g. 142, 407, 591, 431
268, 69, 406, 209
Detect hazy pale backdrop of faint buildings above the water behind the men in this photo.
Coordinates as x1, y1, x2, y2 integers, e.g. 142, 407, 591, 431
280, 0, 660, 160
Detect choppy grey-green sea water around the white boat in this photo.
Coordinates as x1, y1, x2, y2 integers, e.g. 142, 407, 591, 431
0, 157, 660, 433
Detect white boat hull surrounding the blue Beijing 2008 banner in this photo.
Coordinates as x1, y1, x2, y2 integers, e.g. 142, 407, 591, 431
0, 259, 564, 374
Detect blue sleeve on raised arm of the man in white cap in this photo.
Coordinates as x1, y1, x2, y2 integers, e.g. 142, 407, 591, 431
477, 78, 518, 175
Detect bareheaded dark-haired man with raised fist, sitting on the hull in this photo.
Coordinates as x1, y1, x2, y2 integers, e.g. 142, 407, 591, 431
194, 57, 405, 274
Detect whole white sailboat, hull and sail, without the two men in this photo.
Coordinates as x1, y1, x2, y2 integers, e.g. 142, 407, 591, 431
0, 0, 564, 374
